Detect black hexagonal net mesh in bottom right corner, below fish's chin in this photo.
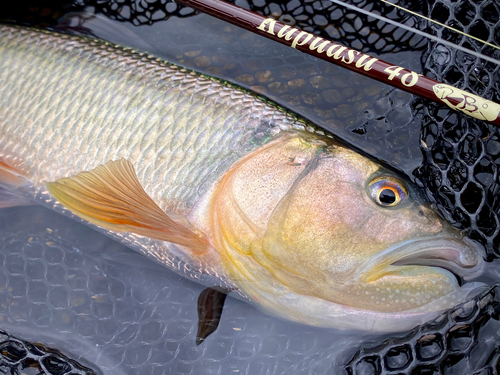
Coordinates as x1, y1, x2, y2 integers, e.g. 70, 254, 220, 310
346, 290, 500, 375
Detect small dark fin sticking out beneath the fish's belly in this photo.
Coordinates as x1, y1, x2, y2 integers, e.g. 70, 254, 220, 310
196, 287, 231, 346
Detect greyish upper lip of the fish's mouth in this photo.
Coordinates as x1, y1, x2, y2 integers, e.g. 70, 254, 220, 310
358, 237, 484, 281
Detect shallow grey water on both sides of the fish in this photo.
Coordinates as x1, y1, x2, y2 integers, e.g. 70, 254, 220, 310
0, 1, 500, 374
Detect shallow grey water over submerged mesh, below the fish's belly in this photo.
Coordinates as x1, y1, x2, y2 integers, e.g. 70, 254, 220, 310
0, 206, 372, 375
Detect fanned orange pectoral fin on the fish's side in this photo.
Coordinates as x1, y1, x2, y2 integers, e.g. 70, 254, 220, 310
47, 159, 208, 252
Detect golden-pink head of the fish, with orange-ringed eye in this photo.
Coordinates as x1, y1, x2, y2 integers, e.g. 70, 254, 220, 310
210, 135, 484, 330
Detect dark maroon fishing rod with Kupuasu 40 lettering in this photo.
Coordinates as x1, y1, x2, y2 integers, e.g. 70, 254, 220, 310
177, 0, 500, 126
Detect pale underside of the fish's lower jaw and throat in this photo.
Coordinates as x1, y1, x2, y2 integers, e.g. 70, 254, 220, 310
216, 234, 487, 333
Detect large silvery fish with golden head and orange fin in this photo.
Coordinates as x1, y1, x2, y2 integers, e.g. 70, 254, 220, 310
0, 25, 486, 332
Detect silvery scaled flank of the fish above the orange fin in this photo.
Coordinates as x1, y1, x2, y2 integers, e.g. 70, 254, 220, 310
0, 26, 303, 211
